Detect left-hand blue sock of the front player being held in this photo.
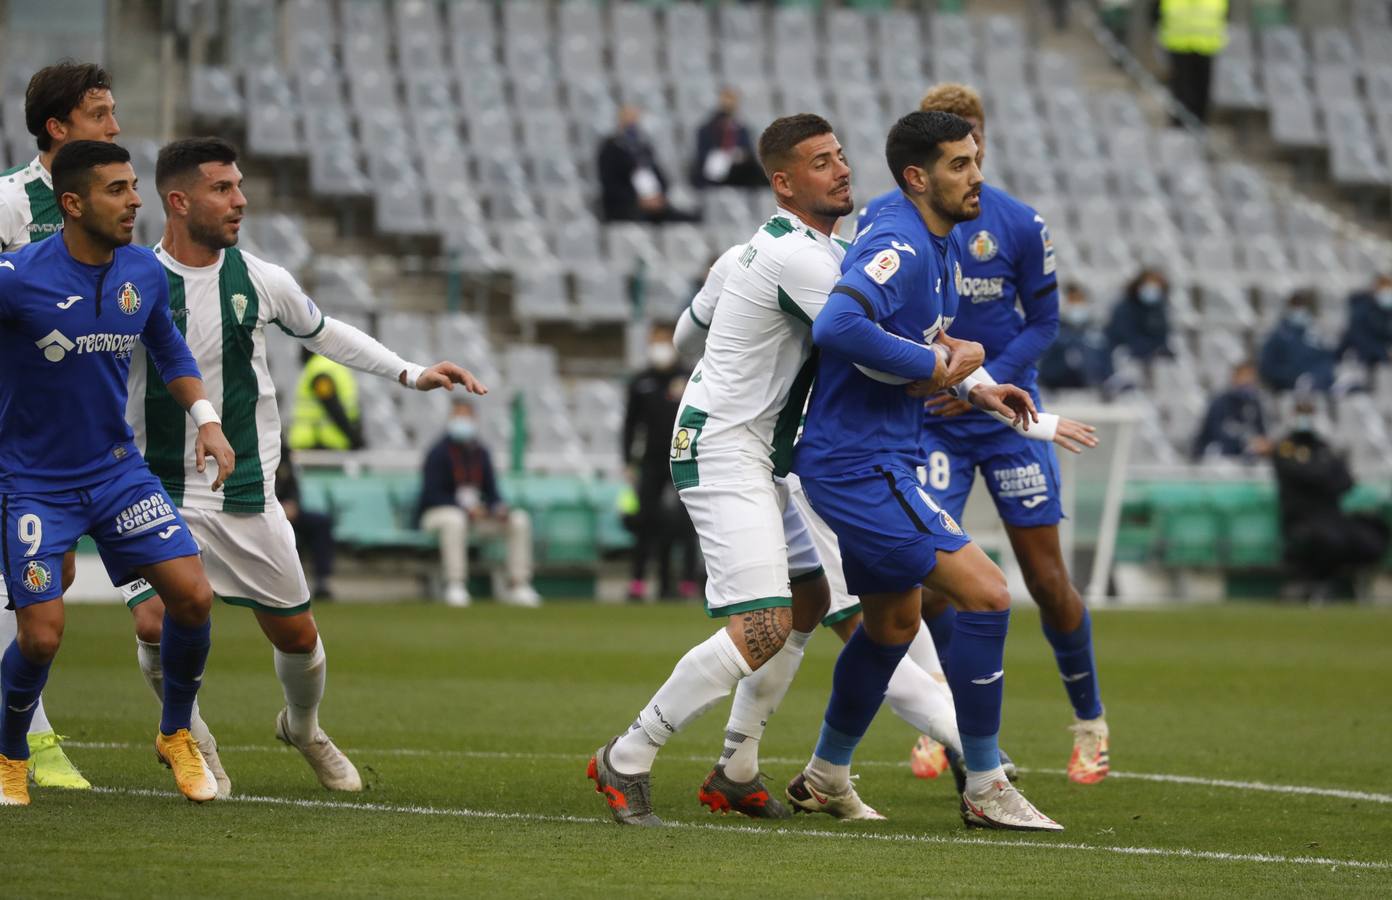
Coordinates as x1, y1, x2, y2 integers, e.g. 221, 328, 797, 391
817, 626, 912, 765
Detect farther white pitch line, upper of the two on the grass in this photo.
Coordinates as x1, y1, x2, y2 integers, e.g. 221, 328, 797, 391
63, 740, 1392, 804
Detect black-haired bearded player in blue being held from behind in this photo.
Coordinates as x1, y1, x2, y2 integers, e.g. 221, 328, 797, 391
786, 111, 1062, 830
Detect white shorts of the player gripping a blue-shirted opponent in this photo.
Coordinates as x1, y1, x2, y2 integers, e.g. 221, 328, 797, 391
678, 476, 792, 618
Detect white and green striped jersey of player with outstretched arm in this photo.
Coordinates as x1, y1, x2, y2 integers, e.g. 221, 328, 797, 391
125, 245, 324, 512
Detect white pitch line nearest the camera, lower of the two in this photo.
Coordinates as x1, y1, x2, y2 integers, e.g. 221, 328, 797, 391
92, 787, 1392, 871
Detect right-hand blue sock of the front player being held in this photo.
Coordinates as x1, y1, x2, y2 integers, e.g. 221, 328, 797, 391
945, 609, 1011, 772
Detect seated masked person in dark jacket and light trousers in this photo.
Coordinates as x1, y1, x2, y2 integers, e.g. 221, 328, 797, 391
419, 401, 541, 606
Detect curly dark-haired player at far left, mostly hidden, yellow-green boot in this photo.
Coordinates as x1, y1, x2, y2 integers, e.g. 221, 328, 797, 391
0, 63, 123, 790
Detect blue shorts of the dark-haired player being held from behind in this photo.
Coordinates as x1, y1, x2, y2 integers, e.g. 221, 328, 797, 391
802, 466, 972, 595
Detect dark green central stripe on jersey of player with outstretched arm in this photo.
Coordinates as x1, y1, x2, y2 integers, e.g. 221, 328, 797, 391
217, 248, 266, 512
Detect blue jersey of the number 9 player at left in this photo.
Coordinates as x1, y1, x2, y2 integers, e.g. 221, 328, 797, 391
0, 236, 199, 492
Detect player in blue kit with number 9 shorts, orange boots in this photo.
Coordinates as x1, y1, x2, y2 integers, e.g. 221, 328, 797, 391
0, 140, 235, 805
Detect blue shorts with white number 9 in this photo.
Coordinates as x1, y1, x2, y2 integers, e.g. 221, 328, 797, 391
0, 465, 198, 608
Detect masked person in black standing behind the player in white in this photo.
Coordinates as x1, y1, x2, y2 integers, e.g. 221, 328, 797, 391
622, 323, 696, 600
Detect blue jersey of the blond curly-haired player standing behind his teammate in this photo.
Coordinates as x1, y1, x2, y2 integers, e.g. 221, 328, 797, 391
864, 185, 1058, 435
